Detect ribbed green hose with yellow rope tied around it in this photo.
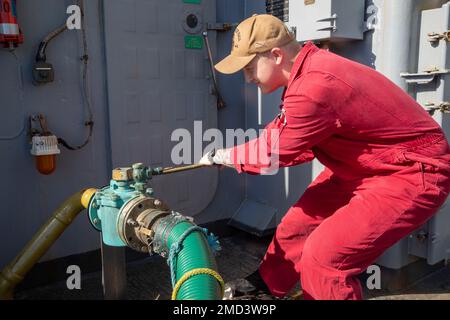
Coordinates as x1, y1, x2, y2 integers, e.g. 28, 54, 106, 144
156, 215, 223, 300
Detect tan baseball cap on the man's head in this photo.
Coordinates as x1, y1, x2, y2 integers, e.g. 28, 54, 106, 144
215, 14, 295, 74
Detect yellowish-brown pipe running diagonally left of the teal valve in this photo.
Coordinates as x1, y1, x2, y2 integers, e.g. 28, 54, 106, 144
0, 190, 84, 300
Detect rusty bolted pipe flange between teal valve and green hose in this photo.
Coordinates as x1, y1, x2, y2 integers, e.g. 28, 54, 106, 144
117, 196, 170, 253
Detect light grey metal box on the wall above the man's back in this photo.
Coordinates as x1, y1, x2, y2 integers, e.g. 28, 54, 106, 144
287, 0, 365, 41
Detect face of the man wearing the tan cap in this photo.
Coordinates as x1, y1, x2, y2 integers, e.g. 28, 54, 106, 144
244, 52, 280, 93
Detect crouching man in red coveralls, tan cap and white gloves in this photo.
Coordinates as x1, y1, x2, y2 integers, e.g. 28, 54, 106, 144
200, 15, 450, 299
